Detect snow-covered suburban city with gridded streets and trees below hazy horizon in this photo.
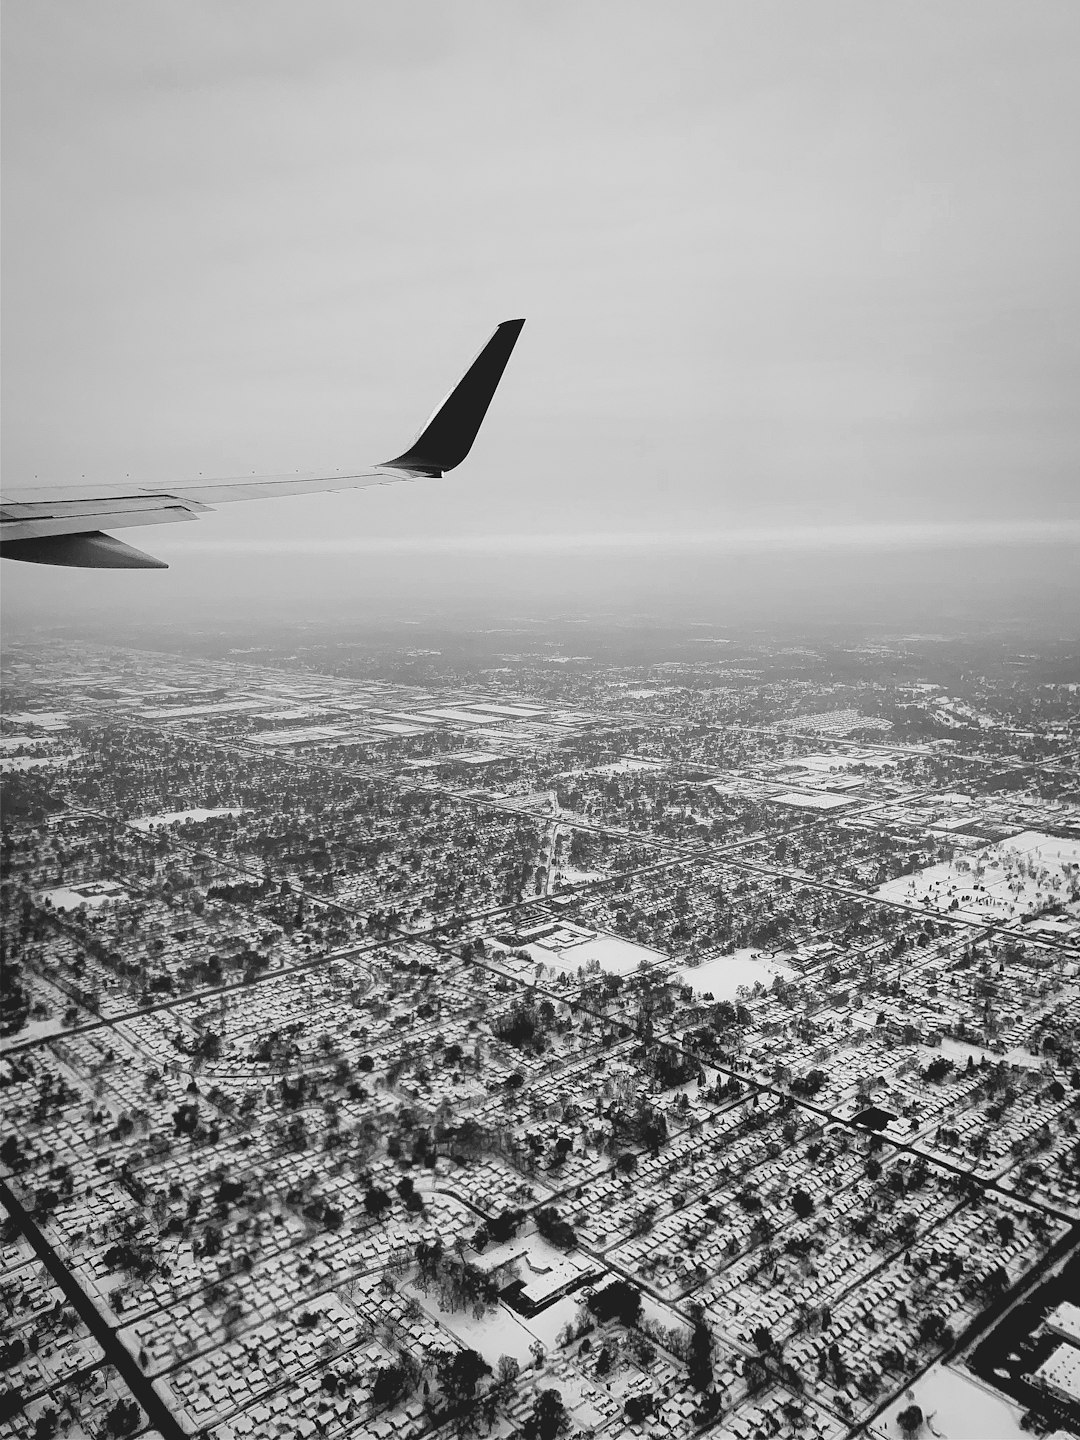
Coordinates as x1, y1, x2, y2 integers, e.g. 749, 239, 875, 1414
0, 626, 1080, 1440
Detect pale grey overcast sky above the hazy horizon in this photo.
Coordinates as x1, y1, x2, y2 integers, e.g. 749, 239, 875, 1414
3, 0, 1080, 624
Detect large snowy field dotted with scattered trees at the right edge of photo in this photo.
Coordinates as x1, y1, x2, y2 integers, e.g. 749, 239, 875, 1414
874, 829, 1080, 920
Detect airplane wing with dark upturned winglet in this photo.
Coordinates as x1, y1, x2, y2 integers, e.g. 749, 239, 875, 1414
0, 320, 524, 570
